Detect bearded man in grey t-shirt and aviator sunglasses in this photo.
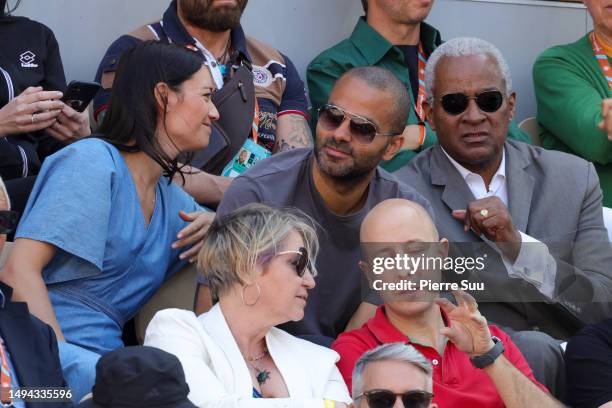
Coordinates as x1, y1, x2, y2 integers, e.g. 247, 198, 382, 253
196, 67, 432, 338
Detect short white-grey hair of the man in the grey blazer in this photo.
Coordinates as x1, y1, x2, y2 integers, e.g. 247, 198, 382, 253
425, 37, 512, 106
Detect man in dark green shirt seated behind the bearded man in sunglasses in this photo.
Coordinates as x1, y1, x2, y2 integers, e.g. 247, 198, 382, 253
306, 0, 530, 171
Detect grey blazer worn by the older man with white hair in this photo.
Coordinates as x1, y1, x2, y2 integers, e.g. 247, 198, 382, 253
394, 140, 612, 338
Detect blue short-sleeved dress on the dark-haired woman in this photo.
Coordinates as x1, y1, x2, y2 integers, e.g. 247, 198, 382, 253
16, 138, 202, 354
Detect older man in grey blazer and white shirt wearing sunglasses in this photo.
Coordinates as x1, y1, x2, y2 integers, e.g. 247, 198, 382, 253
396, 38, 612, 398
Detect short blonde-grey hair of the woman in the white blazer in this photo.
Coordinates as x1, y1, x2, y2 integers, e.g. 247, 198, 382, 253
198, 203, 319, 299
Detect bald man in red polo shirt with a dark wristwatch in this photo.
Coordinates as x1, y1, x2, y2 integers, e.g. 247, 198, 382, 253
332, 199, 562, 408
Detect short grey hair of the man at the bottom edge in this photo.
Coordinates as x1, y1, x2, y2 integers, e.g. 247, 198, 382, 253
352, 343, 433, 399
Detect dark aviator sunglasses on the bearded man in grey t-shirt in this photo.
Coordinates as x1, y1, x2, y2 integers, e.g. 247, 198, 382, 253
319, 104, 401, 144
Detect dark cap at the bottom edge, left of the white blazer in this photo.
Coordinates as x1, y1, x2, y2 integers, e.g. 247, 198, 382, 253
79, 346, 197, 408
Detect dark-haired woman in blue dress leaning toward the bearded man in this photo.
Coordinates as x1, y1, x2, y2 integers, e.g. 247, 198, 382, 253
1, 42, 218, 397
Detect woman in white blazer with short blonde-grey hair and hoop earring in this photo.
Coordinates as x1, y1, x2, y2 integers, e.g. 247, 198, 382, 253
145, 204, 351, 408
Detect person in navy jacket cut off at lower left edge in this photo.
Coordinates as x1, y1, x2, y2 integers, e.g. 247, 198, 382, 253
0, 178, 67, 408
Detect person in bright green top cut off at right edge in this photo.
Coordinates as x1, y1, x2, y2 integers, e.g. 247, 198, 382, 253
533, 0, 612, 207
